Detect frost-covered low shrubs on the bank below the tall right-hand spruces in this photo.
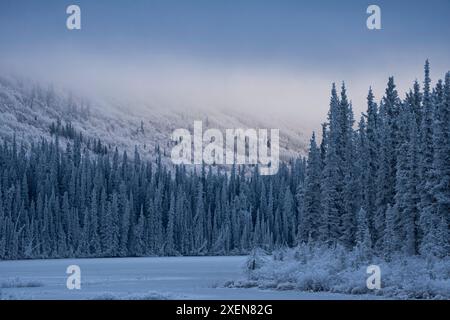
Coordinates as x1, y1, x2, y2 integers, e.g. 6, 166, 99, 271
239, 245, 450, 299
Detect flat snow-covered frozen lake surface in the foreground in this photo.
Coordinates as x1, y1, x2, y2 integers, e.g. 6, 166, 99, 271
0, 257, 371, 300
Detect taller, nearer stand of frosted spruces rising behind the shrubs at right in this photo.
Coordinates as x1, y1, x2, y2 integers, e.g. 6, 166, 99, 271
299, 61, 450, 259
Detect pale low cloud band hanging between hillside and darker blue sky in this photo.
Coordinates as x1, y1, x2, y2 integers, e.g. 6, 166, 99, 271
2, 53, 442, 130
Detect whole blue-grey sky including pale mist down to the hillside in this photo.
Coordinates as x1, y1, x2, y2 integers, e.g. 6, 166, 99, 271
0, 0, 450, 129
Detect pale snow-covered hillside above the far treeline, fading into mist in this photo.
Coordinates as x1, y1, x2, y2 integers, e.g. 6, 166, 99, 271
0, 77, 307, 160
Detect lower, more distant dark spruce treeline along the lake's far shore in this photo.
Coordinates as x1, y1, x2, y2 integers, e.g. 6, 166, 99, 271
0, 135, 305, 259
